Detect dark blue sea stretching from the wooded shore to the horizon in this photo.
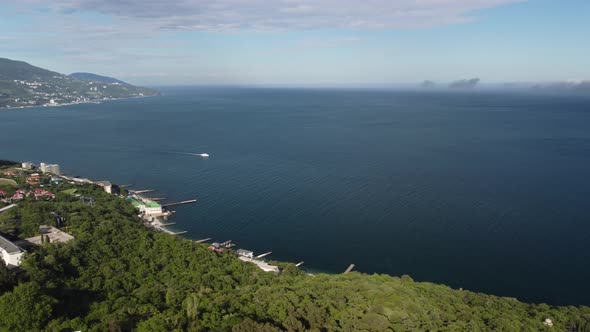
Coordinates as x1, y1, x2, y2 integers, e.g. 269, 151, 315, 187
0, 87, 590, 305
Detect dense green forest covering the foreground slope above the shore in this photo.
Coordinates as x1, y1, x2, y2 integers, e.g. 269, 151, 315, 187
0, 165, 590, 331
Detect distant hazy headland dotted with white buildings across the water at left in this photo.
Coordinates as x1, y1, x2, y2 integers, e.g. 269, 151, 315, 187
0, 58, 157, 108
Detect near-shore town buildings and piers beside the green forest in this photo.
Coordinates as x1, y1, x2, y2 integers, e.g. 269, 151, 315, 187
0, 162, 286, 273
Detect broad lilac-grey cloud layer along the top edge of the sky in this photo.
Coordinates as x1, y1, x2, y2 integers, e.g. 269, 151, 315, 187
25, 0, 523, 31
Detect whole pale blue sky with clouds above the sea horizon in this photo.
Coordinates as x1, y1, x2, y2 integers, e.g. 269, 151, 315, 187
0, 0, 590, 86
